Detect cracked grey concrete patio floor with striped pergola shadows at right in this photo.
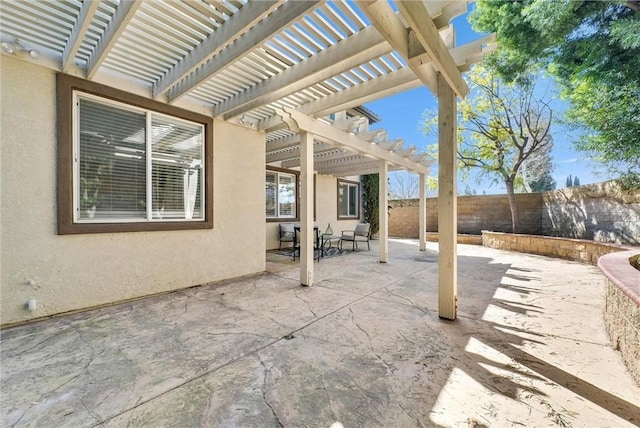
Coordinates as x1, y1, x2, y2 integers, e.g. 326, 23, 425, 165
0, 240, 640, 427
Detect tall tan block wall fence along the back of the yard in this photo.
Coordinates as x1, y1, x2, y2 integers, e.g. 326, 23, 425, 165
389, 181, 640, 245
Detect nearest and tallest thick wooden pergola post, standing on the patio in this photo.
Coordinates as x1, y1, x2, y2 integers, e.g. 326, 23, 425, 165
438, 73, 458, 320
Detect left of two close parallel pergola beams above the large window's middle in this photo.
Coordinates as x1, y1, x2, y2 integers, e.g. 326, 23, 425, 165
152, 0, 283, 98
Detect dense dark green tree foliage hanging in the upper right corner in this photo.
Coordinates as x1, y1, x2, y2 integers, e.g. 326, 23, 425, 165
470, 0, 640, 174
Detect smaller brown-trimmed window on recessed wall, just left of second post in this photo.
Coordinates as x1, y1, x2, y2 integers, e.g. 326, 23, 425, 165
265, 170, 298, 219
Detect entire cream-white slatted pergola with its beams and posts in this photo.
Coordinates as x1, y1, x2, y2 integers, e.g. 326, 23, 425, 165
0, 0, 493, 319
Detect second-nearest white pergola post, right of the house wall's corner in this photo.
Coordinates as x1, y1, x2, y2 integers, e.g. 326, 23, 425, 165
300, 131, 315, 287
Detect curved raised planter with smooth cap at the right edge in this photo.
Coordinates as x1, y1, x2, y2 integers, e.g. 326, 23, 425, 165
598, 251, 640, 385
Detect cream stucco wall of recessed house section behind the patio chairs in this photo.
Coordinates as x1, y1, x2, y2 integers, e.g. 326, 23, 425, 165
263, 175, 362, 250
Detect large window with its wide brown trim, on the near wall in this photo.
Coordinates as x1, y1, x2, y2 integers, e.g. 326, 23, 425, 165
57, 73, 213, 234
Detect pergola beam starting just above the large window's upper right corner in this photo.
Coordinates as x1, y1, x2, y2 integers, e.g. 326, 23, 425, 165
213, 25, 392, 120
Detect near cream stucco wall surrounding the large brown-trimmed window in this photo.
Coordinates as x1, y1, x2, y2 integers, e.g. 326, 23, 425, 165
0, 57, 265, 325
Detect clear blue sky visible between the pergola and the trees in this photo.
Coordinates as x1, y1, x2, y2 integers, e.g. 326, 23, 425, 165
366, 9, 610, 194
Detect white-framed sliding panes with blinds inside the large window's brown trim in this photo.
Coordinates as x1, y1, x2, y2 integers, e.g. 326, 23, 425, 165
73, 91, 205, 223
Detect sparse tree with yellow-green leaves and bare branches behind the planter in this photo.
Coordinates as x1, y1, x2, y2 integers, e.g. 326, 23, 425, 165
425, 66, 553, 233
